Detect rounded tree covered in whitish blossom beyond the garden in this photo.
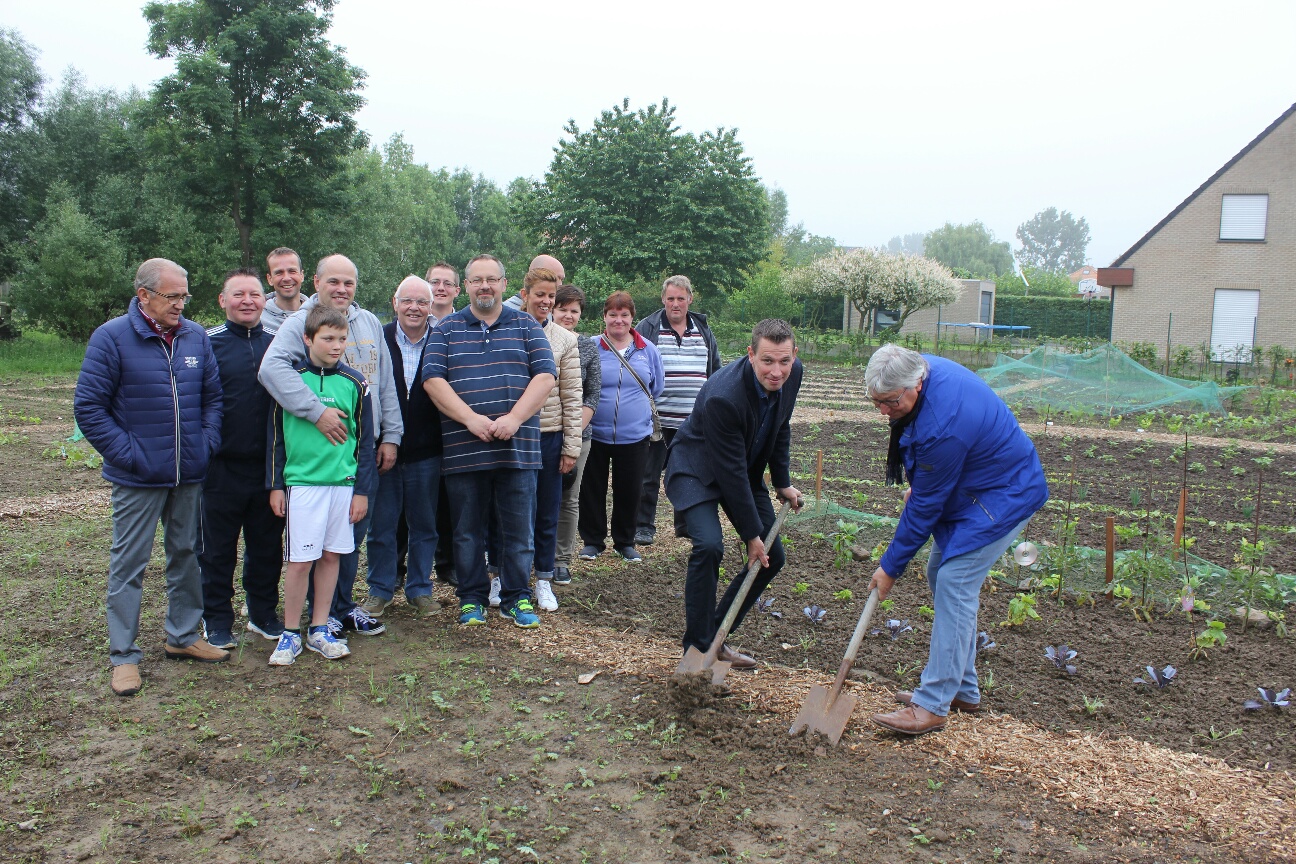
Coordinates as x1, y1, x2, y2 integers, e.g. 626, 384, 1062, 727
789, 249, 963, 332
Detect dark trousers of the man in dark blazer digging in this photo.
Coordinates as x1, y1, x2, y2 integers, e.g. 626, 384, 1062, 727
679, 490, 785, 652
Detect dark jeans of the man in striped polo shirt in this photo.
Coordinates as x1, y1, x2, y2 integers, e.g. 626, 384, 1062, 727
445, 468, 537, 609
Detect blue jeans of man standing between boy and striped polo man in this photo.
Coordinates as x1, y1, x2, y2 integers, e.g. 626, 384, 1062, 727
367, 456, 441, 600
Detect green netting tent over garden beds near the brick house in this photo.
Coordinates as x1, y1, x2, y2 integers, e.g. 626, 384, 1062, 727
977, 345, 1247, 416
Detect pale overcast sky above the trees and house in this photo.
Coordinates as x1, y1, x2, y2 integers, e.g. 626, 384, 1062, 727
0, 0, 1296, 264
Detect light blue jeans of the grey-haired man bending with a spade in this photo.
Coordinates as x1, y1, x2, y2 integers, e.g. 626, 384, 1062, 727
912, 518, 1030, 716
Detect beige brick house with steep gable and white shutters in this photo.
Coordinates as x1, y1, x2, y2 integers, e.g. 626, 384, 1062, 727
1098, 105, 1296, 363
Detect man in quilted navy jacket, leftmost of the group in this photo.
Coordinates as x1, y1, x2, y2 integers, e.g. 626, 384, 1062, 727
73, 258, 229, 696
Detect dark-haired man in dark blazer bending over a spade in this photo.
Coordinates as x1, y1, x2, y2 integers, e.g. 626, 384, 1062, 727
666, 319, 801, 668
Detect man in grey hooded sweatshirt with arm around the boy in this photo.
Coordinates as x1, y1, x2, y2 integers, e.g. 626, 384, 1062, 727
257, 255, 404, 636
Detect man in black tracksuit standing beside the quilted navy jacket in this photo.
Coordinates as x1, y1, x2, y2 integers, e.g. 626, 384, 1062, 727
198, 268, 284, 648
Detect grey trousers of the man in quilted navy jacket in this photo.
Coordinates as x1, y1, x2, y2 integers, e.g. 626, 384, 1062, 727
108, 483, 202, 666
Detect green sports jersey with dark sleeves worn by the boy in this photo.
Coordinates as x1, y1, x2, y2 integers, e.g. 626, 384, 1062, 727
270, 360, 377, 495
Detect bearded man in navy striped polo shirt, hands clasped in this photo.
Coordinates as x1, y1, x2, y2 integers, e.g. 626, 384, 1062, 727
422, 255, 557, 628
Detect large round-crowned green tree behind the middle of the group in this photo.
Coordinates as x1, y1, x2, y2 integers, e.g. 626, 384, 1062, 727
525, 98, 771, 291
